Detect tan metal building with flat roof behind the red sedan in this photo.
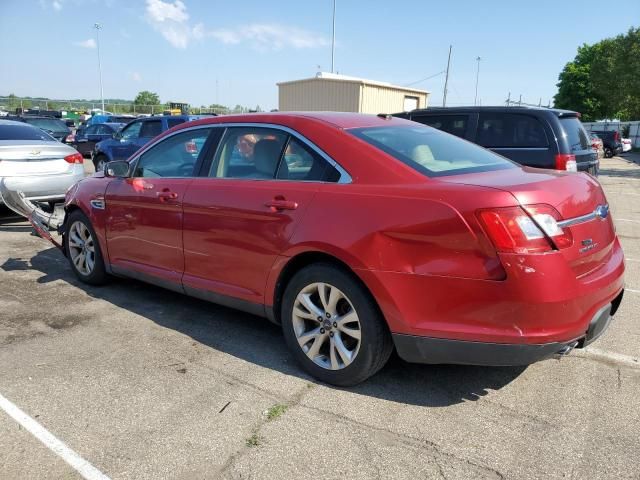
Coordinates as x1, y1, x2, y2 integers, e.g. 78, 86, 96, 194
278, 72, 429, 114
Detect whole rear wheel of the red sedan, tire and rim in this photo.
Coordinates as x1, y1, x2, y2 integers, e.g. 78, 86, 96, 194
281, 264, 393, 386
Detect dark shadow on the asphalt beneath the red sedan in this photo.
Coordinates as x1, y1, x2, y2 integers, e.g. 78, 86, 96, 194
12, 248, 526, 407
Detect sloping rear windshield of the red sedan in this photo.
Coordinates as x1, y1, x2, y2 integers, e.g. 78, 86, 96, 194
349, 126, 516, 177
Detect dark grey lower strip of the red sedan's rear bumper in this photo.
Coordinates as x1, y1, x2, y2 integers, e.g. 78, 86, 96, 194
393, 292, 623, 366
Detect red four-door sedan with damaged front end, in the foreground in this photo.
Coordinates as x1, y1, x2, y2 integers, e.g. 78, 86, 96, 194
55, 113, 624, 385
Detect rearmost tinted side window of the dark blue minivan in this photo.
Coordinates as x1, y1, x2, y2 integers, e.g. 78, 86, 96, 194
477, 113, 549, 148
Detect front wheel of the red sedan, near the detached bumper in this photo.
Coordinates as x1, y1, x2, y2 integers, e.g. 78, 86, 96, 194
63, 210, 108, 285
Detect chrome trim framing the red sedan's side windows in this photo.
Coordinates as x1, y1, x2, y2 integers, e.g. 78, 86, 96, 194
129, 122, 353, 184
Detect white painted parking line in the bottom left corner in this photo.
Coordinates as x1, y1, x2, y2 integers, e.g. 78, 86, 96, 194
0, 394, 109, 480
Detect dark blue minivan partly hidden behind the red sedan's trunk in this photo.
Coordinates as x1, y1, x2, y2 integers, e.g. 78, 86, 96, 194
395, 107, 600, 176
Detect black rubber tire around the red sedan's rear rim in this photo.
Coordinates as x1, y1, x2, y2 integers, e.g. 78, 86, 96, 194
280, 263, 393, 387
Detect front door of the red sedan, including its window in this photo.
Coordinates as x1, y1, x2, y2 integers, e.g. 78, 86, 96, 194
105, 128, 211, 288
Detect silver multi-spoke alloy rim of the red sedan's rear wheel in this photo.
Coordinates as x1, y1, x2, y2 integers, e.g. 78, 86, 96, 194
292, 282, 362, 370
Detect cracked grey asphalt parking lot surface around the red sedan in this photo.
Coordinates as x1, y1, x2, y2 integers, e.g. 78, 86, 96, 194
0, 155, 640, 479
